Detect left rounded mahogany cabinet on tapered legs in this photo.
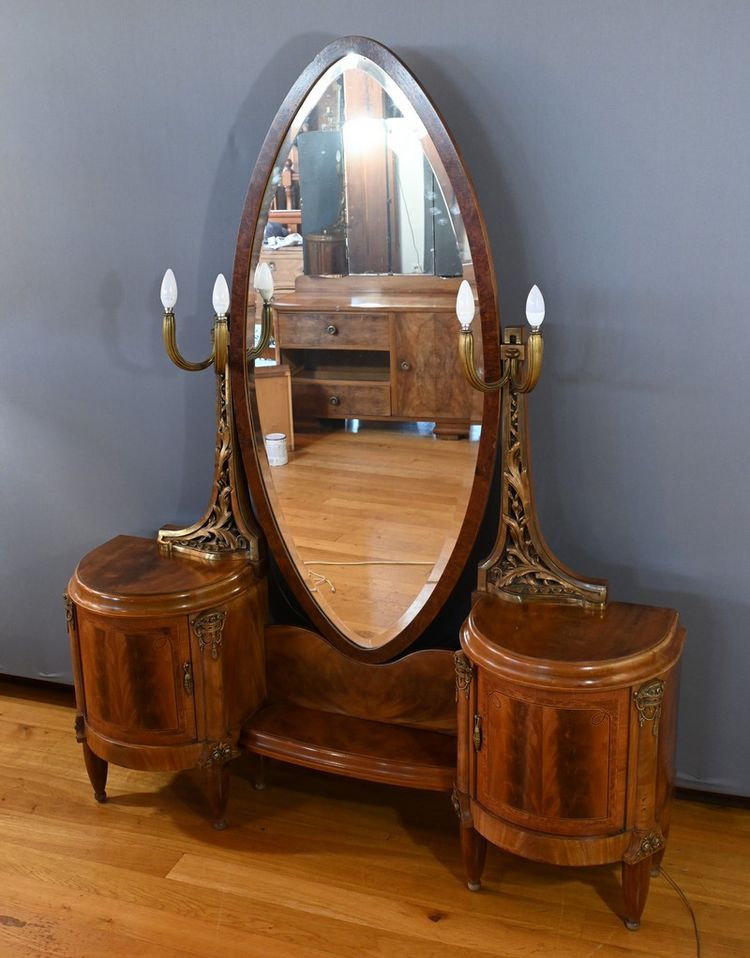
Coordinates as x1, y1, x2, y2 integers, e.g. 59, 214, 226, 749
65, 536, 266, 828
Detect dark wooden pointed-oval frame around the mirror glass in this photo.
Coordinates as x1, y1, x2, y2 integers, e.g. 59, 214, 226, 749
230, 37, 500, 663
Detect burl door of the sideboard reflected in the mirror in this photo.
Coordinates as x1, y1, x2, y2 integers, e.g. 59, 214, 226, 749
391, 312, 481, 421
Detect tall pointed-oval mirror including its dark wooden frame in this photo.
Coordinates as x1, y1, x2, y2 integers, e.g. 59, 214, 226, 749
232, 38, 498, 661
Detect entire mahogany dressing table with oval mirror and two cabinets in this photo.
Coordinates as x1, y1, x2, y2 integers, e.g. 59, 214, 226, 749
66, 37, 684, 927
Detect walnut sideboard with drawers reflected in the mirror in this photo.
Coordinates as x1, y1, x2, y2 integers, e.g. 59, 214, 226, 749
273, 276, 482, 438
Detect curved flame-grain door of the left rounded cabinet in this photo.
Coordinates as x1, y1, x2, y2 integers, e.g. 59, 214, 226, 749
78, 610, 196, 746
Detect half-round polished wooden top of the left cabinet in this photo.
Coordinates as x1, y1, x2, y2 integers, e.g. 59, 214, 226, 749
68, 536, 255, 615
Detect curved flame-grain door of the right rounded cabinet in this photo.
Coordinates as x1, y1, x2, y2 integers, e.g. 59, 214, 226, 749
474, 670, 629, 835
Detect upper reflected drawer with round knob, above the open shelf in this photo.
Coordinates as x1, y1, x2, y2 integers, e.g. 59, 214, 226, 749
276, 310, 390, 349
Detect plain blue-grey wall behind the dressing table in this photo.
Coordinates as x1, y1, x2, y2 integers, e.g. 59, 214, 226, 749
0, 0, 750, 794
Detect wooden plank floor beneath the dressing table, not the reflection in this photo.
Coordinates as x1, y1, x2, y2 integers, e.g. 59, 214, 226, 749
0, 681, 750, 958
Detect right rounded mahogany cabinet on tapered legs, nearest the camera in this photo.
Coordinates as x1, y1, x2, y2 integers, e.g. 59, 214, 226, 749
454, 595, 684, 929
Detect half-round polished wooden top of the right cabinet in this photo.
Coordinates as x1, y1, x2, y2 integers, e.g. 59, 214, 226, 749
461, 594, 685, 688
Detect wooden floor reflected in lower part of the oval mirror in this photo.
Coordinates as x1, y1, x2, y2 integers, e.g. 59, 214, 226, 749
270, 420, 478, 648
